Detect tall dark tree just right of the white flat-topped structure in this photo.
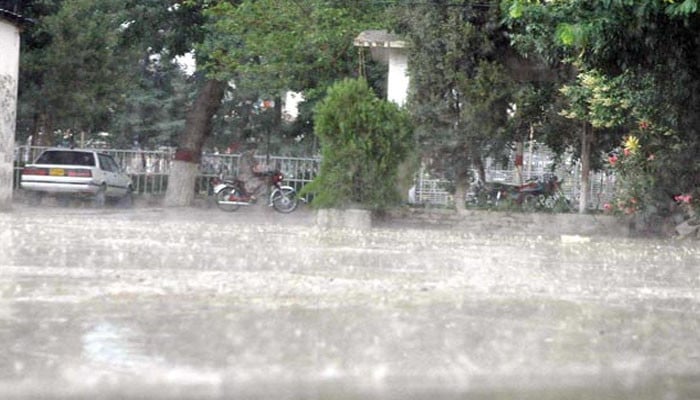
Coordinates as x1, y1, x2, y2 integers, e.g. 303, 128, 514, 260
399, 0, 513, 209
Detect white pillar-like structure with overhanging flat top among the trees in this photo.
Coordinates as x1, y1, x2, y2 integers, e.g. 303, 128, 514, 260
354, 31, 409, 106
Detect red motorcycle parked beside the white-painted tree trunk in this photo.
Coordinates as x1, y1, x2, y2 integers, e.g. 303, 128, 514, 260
213, 170, 299, 214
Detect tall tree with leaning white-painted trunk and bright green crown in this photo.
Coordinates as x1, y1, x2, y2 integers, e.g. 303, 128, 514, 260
157, 0, 394, 205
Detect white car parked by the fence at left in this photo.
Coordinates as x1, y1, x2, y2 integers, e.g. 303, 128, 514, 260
20, 149, 133, 207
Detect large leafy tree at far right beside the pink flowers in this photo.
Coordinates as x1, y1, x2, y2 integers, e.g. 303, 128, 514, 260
504, 0, 700, 219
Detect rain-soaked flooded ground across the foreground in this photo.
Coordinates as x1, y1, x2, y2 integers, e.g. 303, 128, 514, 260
0, 206, 700, 399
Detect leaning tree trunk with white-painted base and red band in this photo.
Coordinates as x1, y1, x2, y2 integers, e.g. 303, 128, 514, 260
163, 79, 227, 207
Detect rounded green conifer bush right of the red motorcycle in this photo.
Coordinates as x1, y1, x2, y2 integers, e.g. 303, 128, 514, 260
303, 79, 413, 210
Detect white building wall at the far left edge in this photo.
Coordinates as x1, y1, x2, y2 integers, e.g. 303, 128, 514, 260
0, 18, 20, 210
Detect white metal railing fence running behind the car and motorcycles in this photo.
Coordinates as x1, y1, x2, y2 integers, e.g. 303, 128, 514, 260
14, 146, 615, 209
